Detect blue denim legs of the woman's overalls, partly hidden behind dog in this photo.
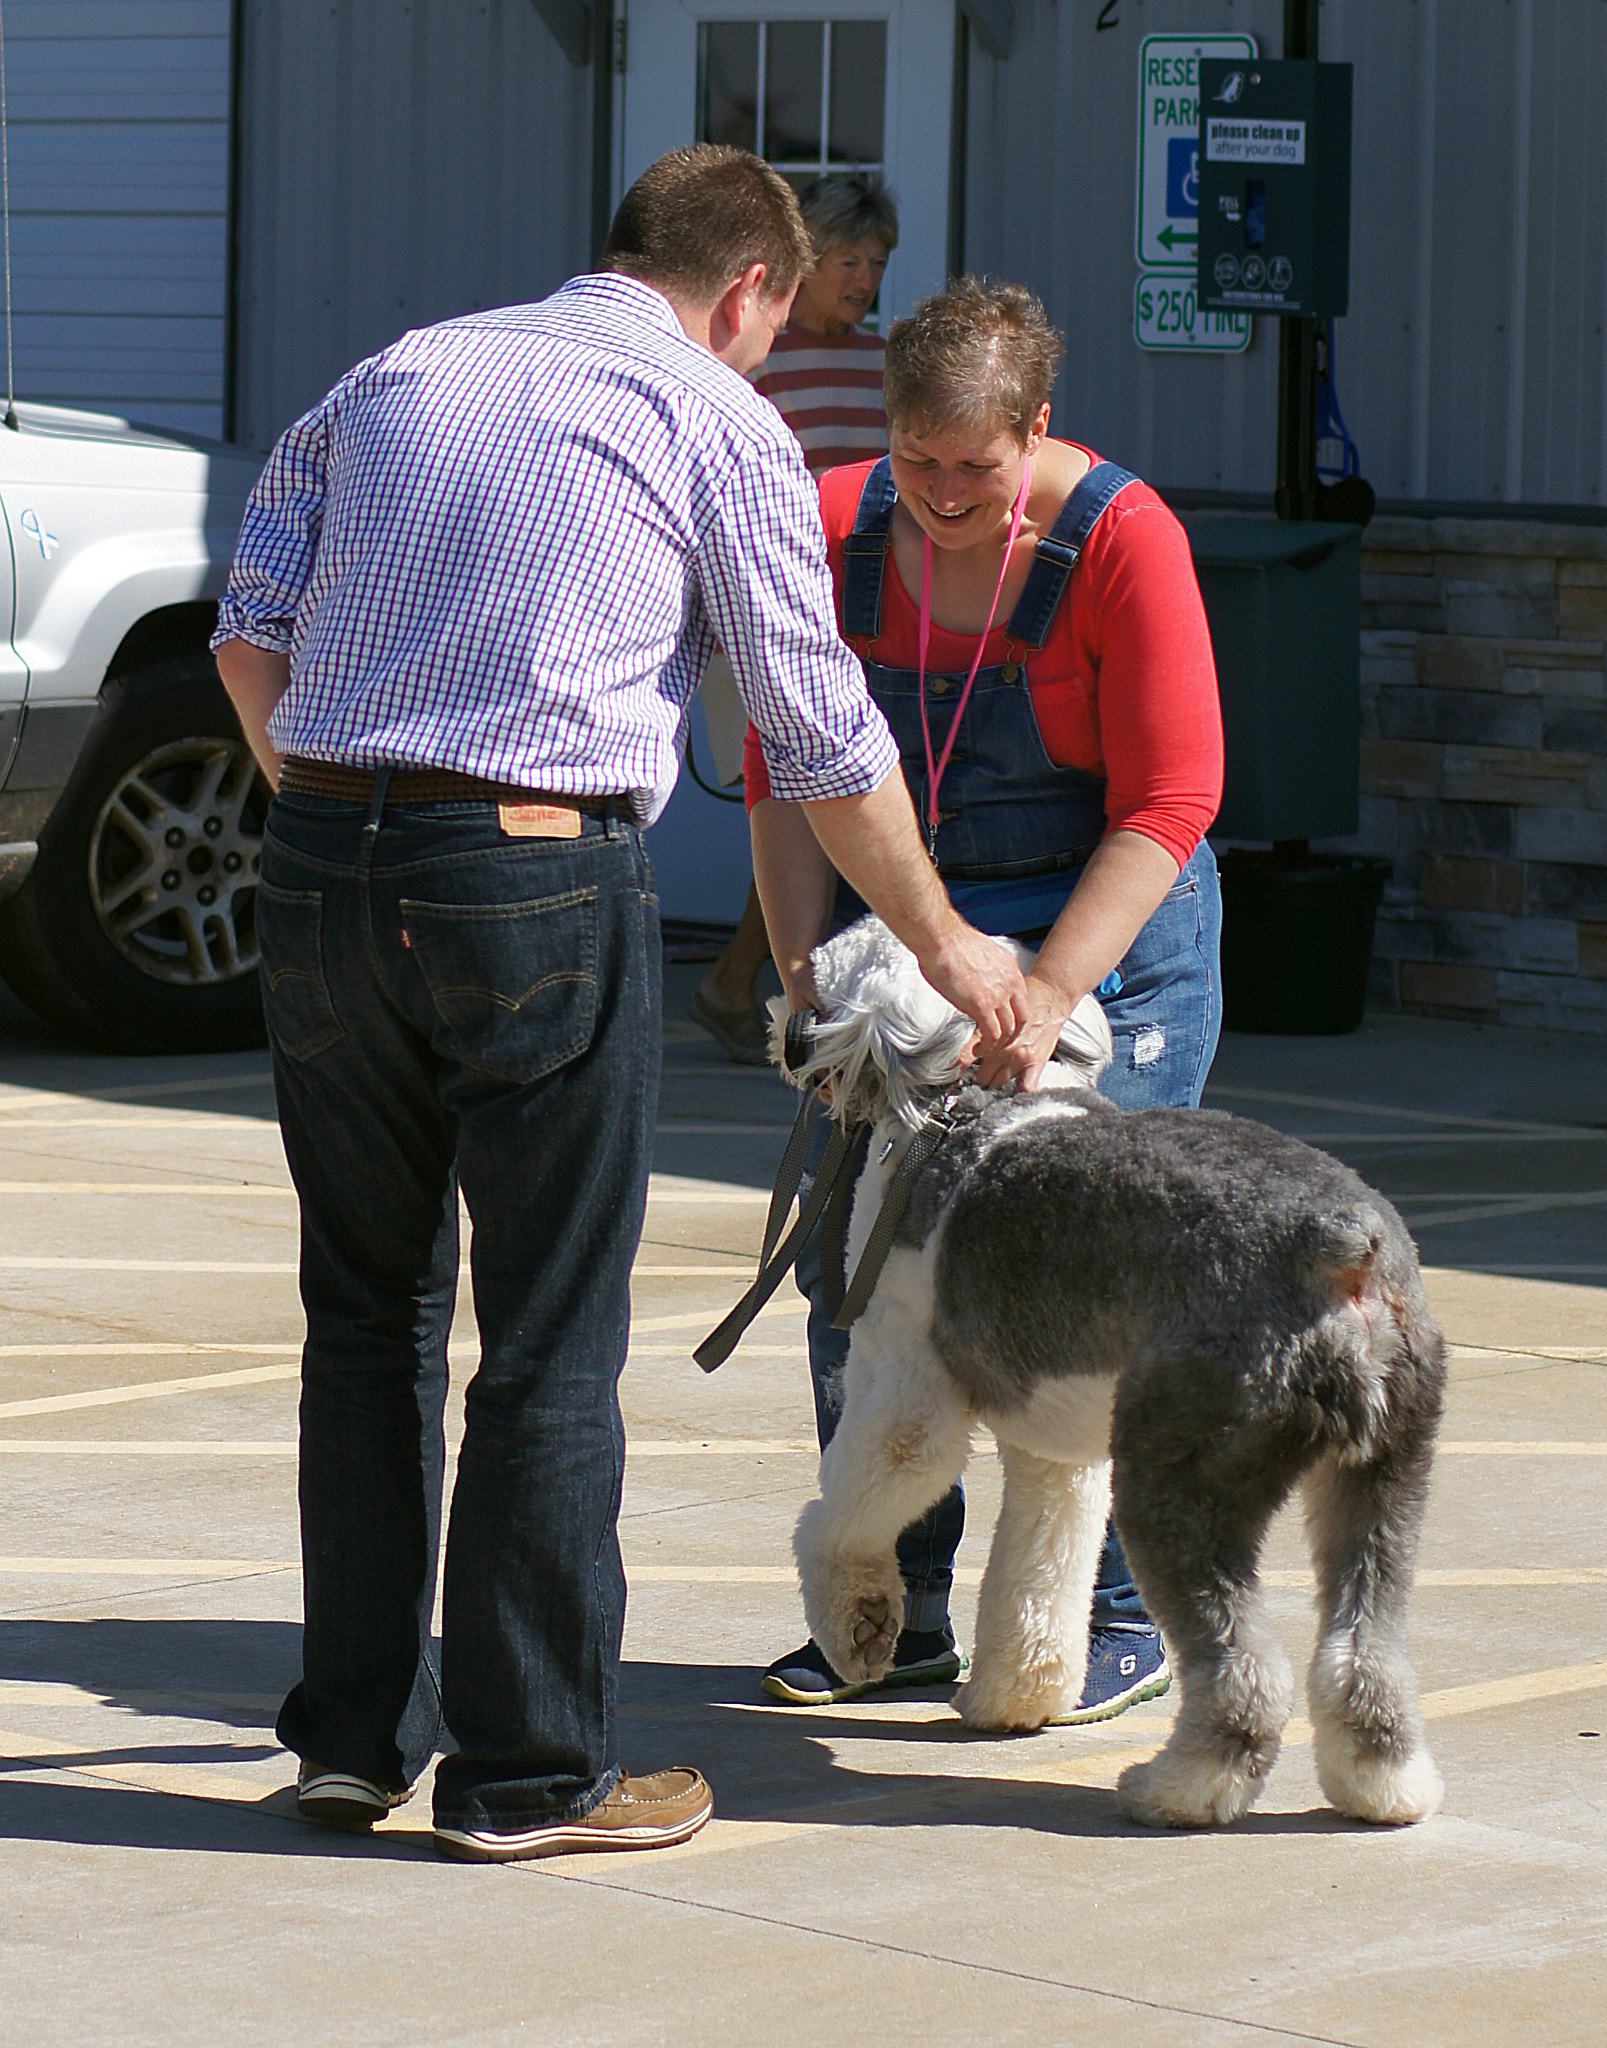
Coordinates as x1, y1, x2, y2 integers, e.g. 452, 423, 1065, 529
796, 840, 1222, 1628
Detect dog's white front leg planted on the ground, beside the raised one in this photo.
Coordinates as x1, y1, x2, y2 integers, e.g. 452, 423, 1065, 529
956, 1444, 1110, 1729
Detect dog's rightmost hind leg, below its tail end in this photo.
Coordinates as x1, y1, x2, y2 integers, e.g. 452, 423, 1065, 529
1304, 1432, 1445, 1823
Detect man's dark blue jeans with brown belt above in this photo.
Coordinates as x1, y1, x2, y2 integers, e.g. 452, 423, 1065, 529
258, 795, 661, 1825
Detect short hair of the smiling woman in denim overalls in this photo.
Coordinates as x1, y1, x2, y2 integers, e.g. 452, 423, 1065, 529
884, 276, 1065, 444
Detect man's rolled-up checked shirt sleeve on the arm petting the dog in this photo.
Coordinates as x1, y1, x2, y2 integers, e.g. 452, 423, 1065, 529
698, 432, 899, 803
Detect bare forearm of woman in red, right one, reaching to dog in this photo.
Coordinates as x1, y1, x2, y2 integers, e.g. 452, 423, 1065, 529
976, 831, 1179, 1087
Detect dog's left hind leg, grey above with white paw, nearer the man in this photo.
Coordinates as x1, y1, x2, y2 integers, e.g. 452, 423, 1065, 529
1114, 1395, 1296, 1827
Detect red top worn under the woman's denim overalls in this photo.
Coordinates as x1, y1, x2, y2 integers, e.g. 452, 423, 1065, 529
743, 442, 1222, 868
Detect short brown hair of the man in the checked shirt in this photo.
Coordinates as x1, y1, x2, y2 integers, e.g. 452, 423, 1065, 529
602, 141, 815, 305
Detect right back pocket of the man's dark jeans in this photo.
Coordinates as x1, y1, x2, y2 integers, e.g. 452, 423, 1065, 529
401, 889, 598, 1085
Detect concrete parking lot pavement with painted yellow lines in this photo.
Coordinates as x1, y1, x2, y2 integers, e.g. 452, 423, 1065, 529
0, 967, 1607, 2048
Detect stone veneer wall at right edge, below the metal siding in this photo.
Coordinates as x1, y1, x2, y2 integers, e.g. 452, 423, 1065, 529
1345, 516, 1607, 1032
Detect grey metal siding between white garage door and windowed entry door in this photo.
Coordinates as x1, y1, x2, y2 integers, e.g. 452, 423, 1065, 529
235, 0, 592, 446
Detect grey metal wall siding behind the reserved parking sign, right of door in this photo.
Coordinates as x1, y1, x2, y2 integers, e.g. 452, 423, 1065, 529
966, 0, 1607, 506
